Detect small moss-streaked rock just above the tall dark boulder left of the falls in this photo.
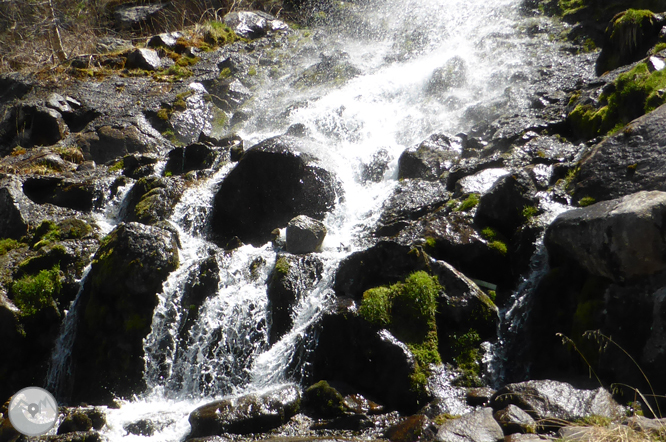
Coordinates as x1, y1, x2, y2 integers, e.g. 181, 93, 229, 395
120, 177, 183, 225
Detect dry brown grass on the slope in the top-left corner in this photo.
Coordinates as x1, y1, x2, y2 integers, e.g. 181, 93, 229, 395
0, 0, 282, 73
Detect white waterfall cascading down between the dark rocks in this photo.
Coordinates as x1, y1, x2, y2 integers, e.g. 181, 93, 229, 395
46, 0, 584, 441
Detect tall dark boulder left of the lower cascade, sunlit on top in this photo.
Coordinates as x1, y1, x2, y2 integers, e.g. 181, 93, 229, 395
71, 223, 178, 403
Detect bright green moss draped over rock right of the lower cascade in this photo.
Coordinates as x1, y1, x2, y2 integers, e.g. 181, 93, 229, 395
359, 271, 442, 391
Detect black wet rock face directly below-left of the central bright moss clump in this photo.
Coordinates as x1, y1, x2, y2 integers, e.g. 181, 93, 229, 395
312, 303, 425, 413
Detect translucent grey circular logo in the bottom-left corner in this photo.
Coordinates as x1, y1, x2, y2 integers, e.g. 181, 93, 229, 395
9, 387, 58, 436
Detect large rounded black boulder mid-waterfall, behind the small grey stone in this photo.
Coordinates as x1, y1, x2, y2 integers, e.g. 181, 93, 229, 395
212, 137, 336, 245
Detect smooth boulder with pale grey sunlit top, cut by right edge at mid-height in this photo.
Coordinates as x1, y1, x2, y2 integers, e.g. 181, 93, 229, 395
545, 191, 666, 282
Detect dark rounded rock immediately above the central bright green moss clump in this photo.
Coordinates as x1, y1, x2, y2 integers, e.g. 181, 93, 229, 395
333, 241, 427, 301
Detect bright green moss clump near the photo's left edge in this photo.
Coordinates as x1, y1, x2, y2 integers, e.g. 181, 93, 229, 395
10, 265, 62, 316
